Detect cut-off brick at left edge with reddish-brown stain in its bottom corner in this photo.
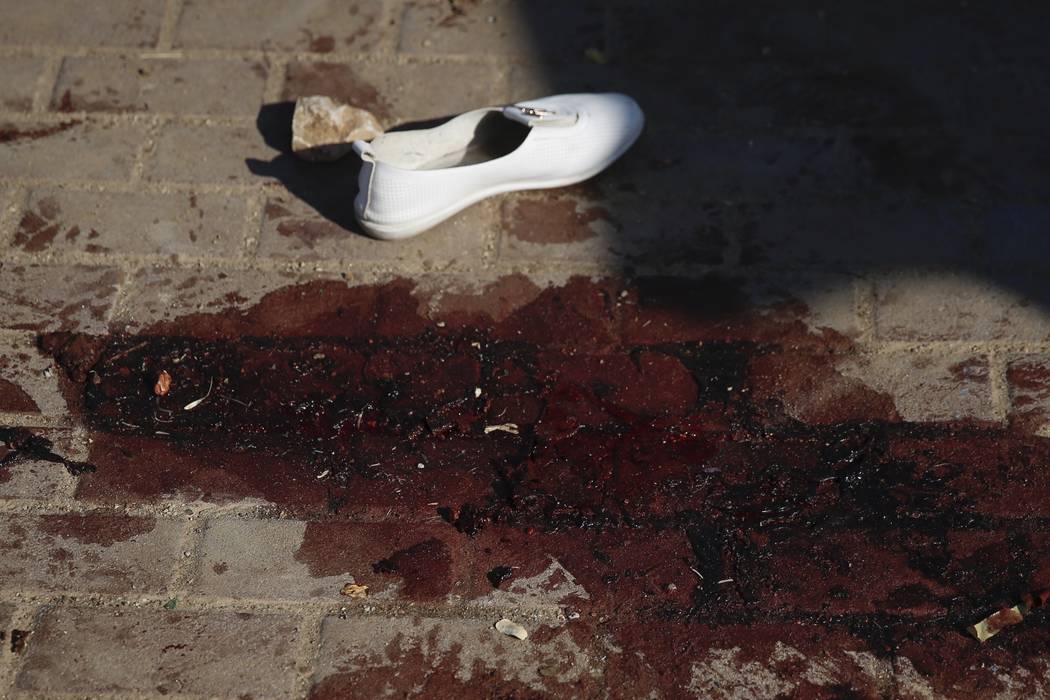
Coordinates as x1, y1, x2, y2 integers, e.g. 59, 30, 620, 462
0, 335, 66, 416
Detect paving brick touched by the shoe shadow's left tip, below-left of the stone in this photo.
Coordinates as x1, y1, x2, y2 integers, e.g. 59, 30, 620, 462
146, 124, 281, 185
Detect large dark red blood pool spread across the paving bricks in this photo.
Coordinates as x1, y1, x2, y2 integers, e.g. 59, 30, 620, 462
34, 277, 1050, 688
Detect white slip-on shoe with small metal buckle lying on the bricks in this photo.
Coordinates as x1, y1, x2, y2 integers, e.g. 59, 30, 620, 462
354, 92, 645, 240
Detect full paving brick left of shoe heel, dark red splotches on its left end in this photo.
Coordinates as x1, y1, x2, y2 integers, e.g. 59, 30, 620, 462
13, 189, 245, 257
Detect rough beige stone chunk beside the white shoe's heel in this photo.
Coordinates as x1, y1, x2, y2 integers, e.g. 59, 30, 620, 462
292, 96, 383, 162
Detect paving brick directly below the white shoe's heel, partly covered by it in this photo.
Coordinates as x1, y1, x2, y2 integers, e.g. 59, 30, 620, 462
258, 192, 498, 265
